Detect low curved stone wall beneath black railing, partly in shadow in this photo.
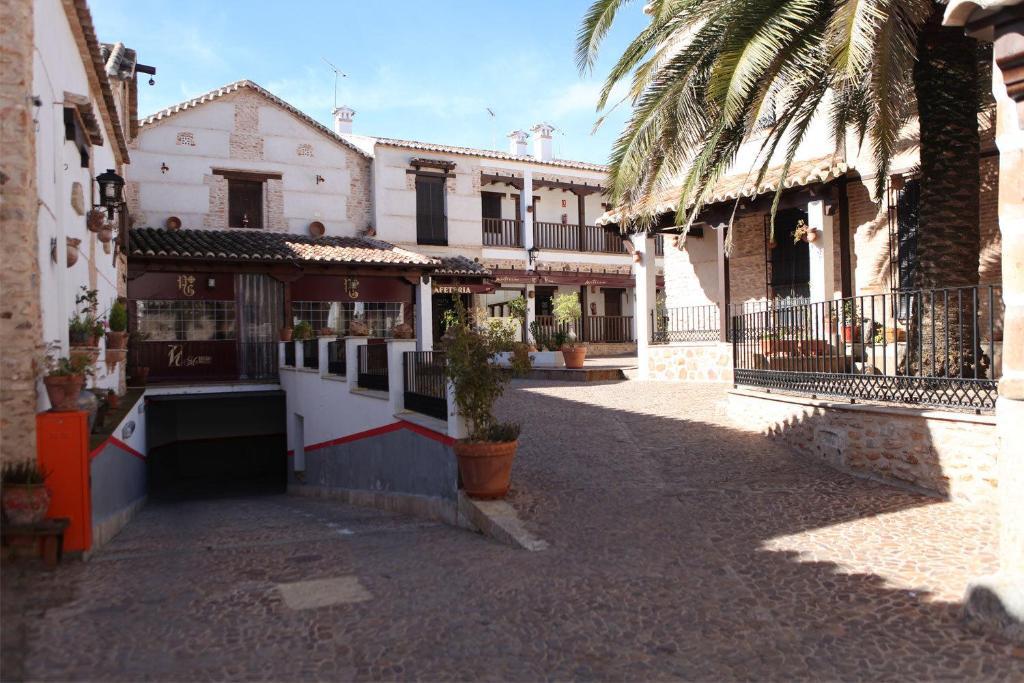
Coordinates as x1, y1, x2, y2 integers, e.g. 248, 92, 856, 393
728, 389, 999, 502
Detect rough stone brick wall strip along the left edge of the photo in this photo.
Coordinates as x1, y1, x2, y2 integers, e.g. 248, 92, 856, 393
0, 0, 43, 462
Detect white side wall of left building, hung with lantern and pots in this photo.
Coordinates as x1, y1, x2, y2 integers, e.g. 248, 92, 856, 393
32, 0, 124, 411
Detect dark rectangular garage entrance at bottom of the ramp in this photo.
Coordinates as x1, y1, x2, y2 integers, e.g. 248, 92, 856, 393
145, 391, 288, 499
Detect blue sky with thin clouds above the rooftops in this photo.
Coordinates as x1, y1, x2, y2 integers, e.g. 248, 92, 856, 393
90, 0, 645, 162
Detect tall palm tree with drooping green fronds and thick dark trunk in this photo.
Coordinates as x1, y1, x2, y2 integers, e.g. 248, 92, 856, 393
577, 0, 980, 376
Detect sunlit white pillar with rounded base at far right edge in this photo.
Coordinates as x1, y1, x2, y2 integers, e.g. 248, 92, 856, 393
945, 0, 1024, 644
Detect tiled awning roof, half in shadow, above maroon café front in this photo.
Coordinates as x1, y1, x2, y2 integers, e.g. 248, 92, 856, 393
128, 227, 440, 269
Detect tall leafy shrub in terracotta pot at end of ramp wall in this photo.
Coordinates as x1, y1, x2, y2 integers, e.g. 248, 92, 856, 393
442, 302, 529, 499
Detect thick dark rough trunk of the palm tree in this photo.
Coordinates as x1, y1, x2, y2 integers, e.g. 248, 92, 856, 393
910, 3, 981, 377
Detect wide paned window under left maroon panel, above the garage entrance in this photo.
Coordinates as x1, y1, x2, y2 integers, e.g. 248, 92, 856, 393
135, 300, 234, 341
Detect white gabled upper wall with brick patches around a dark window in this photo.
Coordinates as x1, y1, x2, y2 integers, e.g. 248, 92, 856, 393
131, 89, 364, 236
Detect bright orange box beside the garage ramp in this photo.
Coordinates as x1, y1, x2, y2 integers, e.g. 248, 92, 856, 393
36, 411, 92, 552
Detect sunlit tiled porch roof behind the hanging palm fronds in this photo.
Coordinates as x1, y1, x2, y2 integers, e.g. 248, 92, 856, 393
595, 156, 851, 225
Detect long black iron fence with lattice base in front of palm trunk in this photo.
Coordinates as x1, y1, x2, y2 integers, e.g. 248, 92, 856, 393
732, 286, 1004, 411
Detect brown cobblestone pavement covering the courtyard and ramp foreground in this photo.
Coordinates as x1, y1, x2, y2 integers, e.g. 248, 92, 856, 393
3, 382, 1024, 681
